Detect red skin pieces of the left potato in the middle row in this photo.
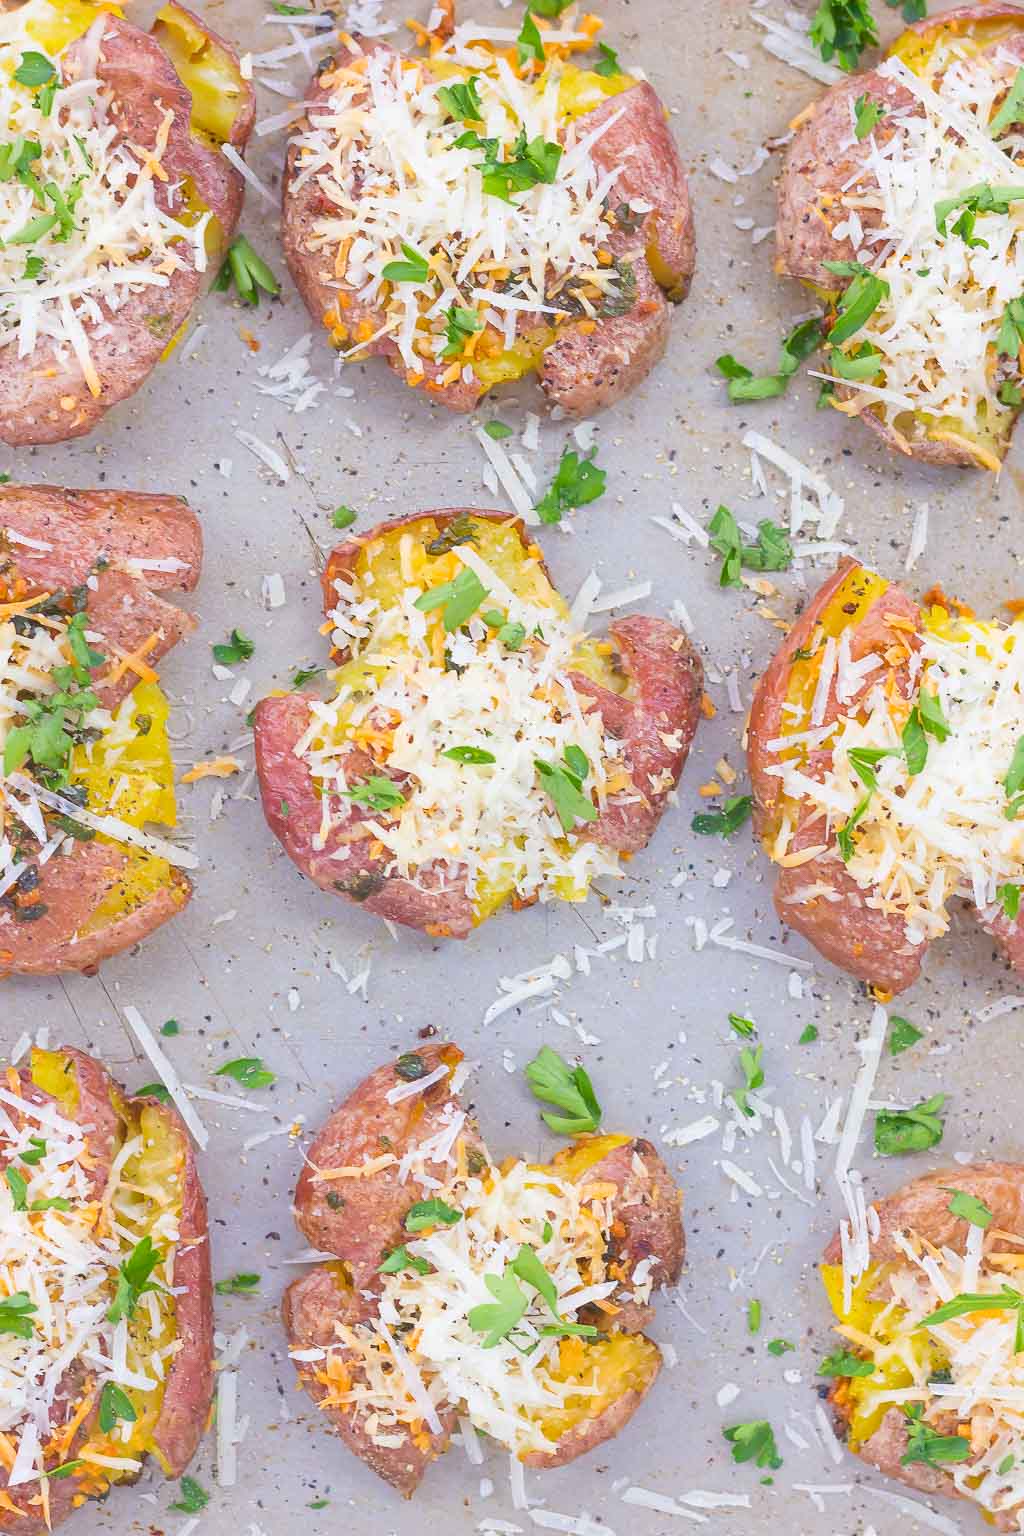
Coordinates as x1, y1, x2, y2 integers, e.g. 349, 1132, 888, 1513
0, 485, 203, 975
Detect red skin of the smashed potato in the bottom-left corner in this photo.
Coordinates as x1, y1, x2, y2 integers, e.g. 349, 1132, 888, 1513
0, 1046, 213, 1536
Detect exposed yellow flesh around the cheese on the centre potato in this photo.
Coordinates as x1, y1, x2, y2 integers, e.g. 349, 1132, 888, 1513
322, 518, 626, 923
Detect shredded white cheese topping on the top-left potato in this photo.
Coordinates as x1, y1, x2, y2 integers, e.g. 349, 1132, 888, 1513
0, 0, 210, 395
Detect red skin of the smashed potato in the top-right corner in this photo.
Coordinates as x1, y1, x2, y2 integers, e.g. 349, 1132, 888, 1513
775, 5, 1024, 468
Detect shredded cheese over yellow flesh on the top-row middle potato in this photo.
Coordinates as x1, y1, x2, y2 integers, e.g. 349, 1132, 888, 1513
288, 29, 635, 386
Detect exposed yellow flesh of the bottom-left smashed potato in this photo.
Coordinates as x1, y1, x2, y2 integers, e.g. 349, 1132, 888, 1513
31, 1049, 186, 1493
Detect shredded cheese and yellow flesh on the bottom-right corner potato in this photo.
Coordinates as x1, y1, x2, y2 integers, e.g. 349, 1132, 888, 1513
824, 1226, 1024, 1530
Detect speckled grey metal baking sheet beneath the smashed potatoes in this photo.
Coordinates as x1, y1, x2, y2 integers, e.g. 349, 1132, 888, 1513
0, 0, 1024, 1536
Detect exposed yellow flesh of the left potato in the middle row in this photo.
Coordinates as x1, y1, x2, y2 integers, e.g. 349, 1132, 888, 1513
71, 682, 178, 934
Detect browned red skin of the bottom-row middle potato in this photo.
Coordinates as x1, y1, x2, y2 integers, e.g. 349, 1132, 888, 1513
282, 1043, 685, 1498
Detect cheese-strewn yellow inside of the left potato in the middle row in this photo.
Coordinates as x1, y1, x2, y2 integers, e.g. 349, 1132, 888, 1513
0, 594, 177, 915
